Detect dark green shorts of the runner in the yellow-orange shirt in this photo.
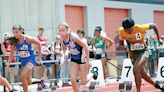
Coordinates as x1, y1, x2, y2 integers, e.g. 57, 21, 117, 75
130, 48, 147, 64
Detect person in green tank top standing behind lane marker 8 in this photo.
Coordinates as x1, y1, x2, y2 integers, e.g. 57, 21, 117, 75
91, 27, 114, 79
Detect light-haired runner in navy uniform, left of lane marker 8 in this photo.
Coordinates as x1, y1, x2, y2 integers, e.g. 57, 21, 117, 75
58, 23, 89, 92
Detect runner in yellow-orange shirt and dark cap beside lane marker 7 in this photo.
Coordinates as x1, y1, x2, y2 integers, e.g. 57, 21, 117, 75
119, 18, 164, 92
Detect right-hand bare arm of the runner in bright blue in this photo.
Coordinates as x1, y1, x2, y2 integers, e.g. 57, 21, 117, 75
26, 36, 43, 64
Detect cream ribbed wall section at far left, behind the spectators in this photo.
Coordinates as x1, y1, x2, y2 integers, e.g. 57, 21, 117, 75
0, 0, 56, 41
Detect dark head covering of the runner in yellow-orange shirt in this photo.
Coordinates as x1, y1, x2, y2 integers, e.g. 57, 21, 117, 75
122, 17, 135, 29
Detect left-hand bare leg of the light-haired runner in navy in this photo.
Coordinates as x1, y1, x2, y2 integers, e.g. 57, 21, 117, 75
70, 62, 80, 92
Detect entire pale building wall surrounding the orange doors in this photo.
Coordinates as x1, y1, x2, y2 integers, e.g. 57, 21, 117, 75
0, 0, 164, 42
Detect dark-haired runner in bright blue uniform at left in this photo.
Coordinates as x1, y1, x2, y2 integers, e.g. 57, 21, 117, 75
7, 25, 43, 92
